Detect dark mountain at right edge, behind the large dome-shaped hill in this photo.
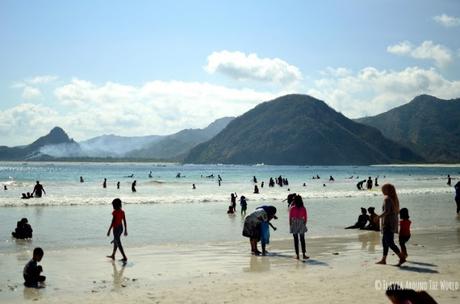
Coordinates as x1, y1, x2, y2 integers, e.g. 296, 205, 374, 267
357, 95, 460, 163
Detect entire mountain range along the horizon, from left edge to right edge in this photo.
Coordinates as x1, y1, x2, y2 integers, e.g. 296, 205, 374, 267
0, 94, 460, 165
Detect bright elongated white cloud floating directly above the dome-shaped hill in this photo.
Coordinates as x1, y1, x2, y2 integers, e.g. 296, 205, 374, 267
205, 51, 302, 85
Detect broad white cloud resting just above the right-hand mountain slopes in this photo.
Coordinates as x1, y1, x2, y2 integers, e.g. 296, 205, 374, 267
307, 67, 460, 118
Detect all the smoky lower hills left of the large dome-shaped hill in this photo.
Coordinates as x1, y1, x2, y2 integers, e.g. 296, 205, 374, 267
0, 117, 233, 161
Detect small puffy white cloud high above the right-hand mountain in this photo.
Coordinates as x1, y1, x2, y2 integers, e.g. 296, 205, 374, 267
387, 40, 452, 67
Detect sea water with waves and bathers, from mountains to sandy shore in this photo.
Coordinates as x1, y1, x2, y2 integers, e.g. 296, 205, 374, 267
0, 162, 460, 253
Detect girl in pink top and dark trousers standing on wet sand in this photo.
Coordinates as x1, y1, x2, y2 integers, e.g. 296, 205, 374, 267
289, 195, 309, 259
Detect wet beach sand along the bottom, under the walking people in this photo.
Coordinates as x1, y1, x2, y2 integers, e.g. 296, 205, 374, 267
0, 228, 460, 304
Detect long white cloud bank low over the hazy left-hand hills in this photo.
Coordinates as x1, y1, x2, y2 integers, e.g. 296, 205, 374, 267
0, 79, 283, 145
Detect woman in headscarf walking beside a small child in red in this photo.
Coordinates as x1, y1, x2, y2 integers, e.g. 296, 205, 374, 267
377, 184, 406, 266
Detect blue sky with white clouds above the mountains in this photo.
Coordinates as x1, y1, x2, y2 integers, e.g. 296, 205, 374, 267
0, 0, 460, 146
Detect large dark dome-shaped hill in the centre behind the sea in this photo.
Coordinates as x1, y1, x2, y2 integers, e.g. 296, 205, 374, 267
185, 94, 423, 165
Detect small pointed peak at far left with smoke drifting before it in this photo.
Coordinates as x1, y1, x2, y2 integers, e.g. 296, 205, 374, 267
0, 127, 81, 160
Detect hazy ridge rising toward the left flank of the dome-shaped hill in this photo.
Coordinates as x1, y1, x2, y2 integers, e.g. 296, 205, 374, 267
127, 117, 234, 160
